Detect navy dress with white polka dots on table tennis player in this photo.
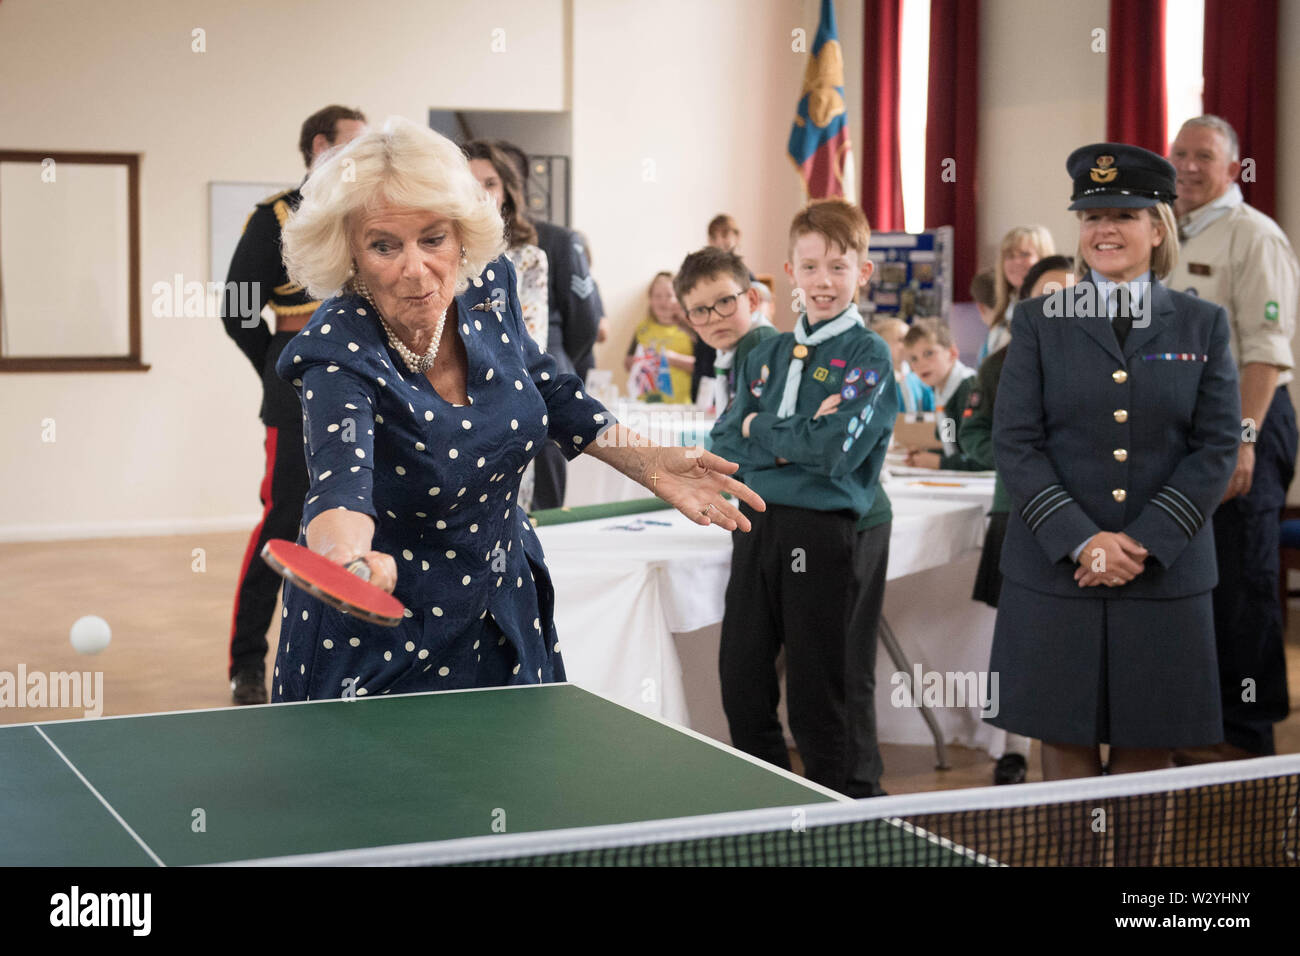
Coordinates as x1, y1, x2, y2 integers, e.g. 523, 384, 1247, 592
272, 259, 614, 701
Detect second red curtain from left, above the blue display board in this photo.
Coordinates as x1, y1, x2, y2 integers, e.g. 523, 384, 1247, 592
926, 0, 980, 298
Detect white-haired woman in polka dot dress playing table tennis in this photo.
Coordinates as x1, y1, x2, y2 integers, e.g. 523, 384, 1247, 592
272, 118, 763, 701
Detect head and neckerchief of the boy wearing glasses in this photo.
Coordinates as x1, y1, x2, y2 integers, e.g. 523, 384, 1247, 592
672, 246, 777, 415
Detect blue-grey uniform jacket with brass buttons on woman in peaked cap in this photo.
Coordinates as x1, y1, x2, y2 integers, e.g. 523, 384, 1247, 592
993, 281, 1242, 598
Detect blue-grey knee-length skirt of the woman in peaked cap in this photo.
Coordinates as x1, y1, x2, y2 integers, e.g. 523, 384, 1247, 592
985, 580, 1223, 748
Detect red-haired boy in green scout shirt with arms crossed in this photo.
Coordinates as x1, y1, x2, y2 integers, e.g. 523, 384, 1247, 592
711, 199, 898, 797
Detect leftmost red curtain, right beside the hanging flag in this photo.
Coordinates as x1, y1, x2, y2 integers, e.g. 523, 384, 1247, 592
861, 0, 902, 232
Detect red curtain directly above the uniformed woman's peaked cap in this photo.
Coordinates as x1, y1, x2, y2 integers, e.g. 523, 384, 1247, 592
1106, 0, 1170, 156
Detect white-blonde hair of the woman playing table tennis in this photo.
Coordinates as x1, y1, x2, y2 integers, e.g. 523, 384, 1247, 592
282, 116, 506, 299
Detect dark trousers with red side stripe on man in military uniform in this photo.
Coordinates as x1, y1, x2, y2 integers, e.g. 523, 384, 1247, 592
230, 421, 309, 676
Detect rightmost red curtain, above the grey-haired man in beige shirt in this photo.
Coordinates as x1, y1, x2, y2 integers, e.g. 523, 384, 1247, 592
1201, 0, 1278, 216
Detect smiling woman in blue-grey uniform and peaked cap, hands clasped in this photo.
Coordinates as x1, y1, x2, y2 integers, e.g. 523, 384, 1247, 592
989, 143, 1240, 779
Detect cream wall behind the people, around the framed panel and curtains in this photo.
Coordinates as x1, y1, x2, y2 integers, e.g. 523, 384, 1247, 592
0, 0, 1300, 540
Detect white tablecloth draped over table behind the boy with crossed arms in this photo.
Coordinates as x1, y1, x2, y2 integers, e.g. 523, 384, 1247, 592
537, 494, 1004, 753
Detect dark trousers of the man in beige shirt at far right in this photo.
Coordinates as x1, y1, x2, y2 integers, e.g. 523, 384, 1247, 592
1214, 385, 1296, 754
